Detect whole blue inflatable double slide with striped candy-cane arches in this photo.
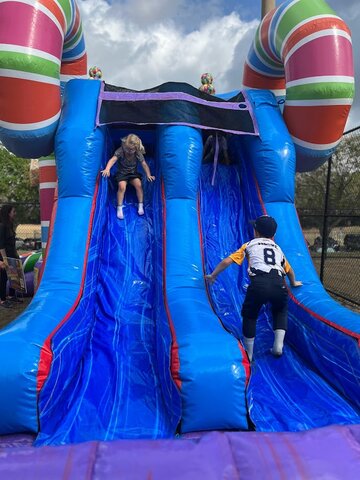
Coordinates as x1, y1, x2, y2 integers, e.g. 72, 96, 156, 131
0, 0, 360, 479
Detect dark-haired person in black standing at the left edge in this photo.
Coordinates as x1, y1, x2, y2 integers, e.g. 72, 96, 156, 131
0, 205, 21, 308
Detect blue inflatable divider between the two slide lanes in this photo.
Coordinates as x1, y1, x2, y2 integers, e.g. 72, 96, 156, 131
159, 126, 248, 432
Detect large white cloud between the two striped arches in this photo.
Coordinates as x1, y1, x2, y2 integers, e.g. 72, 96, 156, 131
80, 0, 257, 92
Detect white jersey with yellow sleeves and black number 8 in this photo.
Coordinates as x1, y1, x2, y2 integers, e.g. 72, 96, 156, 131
229, 238, 290, 276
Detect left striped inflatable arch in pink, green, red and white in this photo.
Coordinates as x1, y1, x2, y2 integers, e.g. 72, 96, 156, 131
0, 0, 87, 158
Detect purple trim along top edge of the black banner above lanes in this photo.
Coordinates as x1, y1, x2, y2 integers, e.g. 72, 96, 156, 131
100, 92, 249, 110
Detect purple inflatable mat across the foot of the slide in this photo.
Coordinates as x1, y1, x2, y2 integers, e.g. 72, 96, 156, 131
0, 425, 360, 480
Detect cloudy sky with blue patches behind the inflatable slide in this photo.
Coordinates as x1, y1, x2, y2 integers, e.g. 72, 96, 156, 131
78, 0, 360, 128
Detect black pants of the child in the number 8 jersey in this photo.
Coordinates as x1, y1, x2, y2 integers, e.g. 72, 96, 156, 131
241, 270, 288, 338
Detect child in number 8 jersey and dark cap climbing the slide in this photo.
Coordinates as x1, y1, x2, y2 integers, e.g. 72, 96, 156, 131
205, 215, 302, 361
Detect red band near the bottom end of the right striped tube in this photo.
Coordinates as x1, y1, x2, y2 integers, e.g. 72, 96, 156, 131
284, 104, 350, 145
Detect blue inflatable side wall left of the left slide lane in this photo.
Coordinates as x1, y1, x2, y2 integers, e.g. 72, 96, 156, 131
0, 81, 104, 433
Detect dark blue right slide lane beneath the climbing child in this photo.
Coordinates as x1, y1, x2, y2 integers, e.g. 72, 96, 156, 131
201, 160, 360, 431
